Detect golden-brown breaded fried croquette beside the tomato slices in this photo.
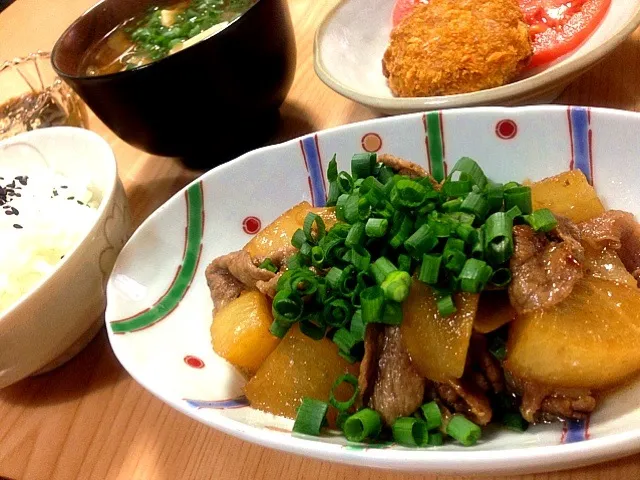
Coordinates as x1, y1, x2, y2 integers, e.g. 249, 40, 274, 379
382, 0, 533, 97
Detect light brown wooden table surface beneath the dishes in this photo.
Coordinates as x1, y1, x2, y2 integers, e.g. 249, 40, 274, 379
0, 0, 640, 480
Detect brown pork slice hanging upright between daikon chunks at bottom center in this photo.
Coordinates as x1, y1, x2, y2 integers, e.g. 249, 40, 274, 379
359, 325, 426, 425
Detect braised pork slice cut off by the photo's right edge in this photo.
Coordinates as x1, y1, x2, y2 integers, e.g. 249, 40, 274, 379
578, 210, 640, 286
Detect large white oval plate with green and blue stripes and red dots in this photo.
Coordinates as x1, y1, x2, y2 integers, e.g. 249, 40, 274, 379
106, 106, 640, 474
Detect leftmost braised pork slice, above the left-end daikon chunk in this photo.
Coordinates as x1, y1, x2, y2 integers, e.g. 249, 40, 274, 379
205, 250, 276, 313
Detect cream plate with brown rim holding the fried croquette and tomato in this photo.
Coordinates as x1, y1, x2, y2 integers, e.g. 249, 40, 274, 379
314, 0, 640, 114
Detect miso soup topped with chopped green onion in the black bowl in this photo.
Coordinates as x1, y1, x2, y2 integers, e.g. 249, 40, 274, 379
80, 0, 257, 75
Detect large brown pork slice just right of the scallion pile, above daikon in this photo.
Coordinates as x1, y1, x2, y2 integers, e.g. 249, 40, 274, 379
509, 217, 584, 314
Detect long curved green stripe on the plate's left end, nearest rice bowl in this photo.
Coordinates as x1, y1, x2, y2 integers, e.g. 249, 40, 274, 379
111, 182, 204, 333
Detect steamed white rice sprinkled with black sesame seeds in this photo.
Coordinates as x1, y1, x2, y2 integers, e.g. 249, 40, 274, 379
0, 168, 100, 314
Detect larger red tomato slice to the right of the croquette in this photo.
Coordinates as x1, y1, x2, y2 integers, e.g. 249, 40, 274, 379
518, 0, 611, 67
